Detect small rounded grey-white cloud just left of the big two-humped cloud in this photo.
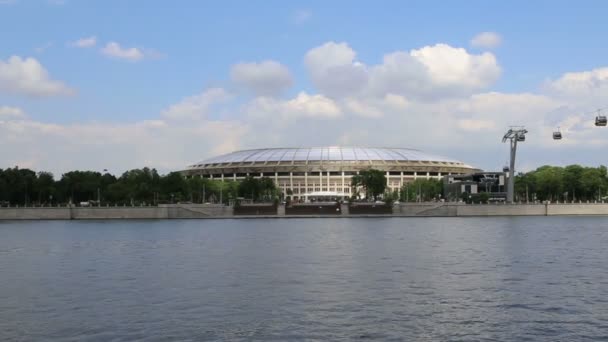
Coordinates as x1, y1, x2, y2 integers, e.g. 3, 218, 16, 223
230, 61, 293, 96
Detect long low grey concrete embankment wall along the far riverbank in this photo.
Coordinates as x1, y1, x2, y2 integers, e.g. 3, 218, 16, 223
0, 203, 608, 220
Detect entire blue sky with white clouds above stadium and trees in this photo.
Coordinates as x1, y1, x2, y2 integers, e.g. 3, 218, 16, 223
0, 0, 608, 176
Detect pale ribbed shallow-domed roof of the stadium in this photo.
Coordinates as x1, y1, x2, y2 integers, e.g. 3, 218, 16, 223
190, 146, 463, 166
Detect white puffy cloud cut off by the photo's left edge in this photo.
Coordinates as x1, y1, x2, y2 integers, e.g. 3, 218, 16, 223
0, 56, 75, 96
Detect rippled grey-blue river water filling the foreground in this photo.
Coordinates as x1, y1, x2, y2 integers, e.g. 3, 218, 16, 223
0, 217, 608, 341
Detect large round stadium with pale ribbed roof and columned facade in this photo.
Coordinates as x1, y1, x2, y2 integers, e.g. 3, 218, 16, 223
182, 146, 479, 200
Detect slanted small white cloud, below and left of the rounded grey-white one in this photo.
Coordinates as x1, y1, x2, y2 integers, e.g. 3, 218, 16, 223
161, 88, 232, 120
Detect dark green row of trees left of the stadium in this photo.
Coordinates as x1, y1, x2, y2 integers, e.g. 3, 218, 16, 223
0, 167, 279, 206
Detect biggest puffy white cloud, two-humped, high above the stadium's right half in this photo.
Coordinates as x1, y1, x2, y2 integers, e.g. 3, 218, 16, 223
304, 42, 501, 100
